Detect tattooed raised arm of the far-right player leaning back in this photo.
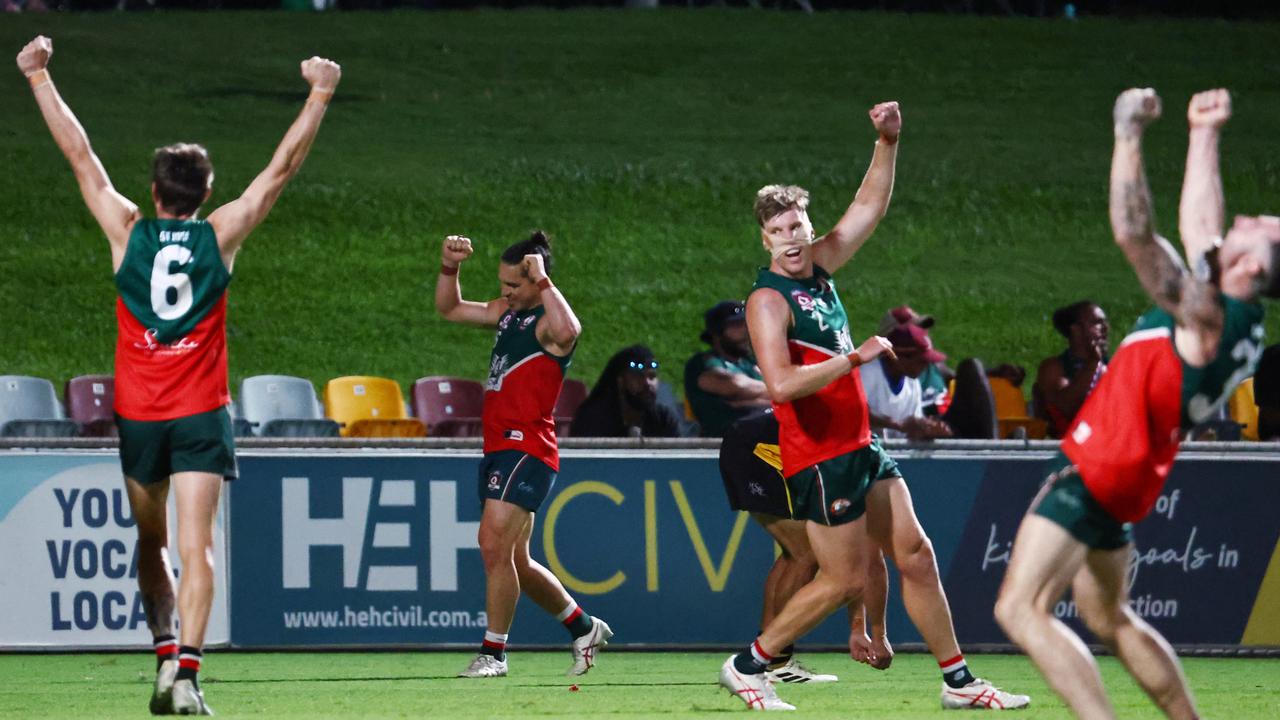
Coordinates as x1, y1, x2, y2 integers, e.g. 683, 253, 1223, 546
1110, 88, 1222, 366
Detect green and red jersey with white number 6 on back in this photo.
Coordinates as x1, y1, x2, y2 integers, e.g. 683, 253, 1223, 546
115, 218, 232, 420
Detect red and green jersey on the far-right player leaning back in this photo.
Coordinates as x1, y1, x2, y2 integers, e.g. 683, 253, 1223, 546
1062, 296, 1263, 523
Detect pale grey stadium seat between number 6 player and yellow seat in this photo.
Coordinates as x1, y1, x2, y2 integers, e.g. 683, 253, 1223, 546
239, 375, 340, 437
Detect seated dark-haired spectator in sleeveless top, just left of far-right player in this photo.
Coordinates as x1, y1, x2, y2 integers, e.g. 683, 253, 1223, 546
1032, 300, 1110, 438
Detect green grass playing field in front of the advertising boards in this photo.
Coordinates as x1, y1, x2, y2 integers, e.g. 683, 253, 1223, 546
0, 652, 1280, 720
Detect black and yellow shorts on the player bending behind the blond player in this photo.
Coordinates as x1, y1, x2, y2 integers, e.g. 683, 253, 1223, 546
719, 410, 792, 519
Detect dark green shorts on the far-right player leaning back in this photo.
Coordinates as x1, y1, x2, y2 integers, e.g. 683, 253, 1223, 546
1030, 452, 1133, 550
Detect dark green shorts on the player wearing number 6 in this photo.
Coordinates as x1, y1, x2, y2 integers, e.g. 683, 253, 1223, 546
115, 407, 239, 484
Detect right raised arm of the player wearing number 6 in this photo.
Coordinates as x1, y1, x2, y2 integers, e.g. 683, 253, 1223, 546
209, 58, 342, 268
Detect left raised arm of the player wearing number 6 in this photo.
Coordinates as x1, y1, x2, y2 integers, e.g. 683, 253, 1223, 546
18, 36, 141, 268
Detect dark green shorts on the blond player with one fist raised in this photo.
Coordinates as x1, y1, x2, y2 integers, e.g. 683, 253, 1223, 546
787, 437, 902, 525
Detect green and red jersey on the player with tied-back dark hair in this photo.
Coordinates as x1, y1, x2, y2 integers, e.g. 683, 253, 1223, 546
483, 305, 573, 470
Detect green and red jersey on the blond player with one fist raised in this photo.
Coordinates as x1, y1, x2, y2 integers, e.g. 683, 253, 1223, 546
751, 265, 872, 478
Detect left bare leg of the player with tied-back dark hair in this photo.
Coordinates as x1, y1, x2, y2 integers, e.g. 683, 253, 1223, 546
479, 500, 532, 635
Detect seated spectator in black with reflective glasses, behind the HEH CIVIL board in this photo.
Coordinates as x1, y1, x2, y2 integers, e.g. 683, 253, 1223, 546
570, 345, 680, 437
